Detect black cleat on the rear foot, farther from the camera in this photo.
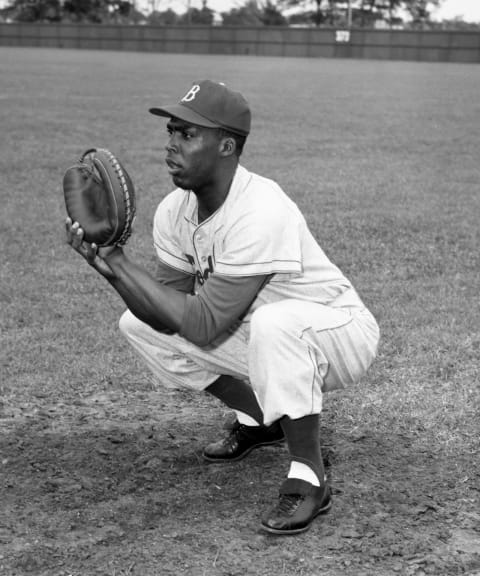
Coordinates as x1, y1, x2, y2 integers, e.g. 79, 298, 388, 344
203, 420, 285, 462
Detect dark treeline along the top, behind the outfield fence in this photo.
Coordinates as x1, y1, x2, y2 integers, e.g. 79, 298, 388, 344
0, 0, 480, 29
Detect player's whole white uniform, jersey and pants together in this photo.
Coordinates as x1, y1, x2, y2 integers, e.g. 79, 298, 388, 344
120, 167, 379, 424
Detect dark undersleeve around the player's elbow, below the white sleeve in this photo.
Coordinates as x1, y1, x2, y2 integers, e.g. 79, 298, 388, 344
179, 273, 270, 346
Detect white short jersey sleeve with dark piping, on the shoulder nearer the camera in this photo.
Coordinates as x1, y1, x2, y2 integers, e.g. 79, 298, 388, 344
215, 203, 302, 276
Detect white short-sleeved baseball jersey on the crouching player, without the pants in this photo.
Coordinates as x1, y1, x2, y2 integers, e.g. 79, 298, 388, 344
153, 166, 363, 320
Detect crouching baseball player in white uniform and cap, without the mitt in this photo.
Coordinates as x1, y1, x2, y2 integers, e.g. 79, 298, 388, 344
67, 80, 379, 534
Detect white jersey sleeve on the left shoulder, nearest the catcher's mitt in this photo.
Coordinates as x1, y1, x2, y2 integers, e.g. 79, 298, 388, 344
153, 190, 195, 275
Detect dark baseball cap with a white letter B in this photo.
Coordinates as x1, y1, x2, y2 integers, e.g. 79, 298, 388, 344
149, 80, 251, 136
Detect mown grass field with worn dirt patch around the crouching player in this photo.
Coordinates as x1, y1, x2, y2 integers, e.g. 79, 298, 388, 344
0, 48, 480, 576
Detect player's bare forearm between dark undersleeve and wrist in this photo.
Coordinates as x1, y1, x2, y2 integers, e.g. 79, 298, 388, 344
106, 253, 186, 332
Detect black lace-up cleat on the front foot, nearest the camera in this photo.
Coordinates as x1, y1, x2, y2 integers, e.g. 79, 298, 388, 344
261, 478, 332, 535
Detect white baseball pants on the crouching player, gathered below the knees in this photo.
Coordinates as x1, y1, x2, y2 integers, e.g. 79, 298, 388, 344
119, 300, 379, 425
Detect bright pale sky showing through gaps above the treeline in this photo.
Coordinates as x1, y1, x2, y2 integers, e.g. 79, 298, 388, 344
164, 0, 480, 22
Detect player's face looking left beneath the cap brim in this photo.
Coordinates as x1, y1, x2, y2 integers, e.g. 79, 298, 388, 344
165, 118, 220, 190
